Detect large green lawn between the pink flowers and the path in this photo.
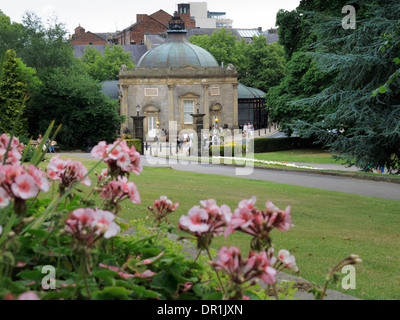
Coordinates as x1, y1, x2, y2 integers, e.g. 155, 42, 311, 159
44, 157, 400, 299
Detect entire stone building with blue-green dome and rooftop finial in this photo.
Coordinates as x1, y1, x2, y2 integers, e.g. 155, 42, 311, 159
118, 16, 239, 139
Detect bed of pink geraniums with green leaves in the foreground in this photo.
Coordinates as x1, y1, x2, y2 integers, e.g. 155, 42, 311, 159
0, 135, 359, 300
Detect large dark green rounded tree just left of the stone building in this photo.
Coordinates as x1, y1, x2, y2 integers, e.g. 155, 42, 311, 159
29, 62, 124, 149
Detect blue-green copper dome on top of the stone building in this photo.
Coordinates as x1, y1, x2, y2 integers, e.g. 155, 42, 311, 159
136, 30, 218, 68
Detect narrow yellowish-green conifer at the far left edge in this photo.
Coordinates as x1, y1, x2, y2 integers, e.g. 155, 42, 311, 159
0, 50, 34, 136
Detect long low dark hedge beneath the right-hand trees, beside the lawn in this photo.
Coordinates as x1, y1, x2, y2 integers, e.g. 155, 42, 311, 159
254, 137, 316, 153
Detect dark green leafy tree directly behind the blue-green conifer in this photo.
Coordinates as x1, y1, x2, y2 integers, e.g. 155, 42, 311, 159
266, 0, 352, 136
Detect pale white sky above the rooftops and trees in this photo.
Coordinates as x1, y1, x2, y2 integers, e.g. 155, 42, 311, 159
0, 0, 300, 34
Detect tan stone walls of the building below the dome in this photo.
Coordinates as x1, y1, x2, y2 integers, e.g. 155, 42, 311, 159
119, 65, 238, 139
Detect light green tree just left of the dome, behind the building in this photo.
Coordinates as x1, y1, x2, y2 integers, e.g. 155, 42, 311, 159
81, 45, 135, 81
